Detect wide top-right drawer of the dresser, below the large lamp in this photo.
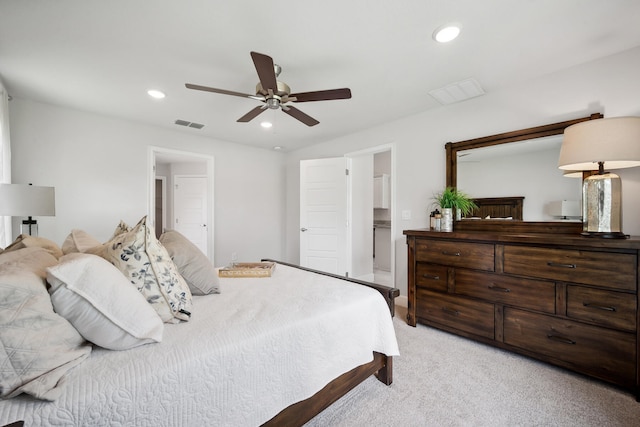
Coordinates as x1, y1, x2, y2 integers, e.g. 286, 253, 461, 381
504, 245, 636, 291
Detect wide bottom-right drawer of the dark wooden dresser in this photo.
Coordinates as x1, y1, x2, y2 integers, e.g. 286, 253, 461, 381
504, 307, 636, 386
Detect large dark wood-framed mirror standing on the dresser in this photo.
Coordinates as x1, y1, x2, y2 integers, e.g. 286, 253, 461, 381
445, 113, 603, 233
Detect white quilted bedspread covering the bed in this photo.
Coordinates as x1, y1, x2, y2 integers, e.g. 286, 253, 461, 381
0, 264, 399, 427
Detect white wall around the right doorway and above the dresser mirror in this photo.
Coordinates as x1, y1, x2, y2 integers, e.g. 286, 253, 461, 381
286, 48, 640, 295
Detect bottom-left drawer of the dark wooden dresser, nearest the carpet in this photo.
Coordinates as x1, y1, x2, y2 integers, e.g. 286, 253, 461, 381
416, 289, 495, 339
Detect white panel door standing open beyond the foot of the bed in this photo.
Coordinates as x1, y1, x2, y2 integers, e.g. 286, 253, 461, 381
300, 157, 349, 276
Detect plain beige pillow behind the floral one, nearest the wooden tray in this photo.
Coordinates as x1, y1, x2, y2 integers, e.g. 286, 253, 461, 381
160, 230, 220, 295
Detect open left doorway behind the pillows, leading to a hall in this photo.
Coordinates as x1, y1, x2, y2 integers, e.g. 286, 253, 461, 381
147, 147, 214, 263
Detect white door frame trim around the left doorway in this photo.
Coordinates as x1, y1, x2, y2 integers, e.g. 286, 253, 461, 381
147, 145, 215, 265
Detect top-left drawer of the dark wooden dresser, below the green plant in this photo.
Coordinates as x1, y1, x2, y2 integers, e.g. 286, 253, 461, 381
416, 239, 495, 271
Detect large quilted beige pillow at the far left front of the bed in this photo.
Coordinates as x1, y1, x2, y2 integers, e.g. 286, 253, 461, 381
0, 247, 91, 400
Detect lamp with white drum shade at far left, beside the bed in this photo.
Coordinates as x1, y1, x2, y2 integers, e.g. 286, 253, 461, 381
0, 184, 56, 236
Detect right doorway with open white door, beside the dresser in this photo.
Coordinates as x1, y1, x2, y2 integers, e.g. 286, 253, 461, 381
299, 144, 396, 286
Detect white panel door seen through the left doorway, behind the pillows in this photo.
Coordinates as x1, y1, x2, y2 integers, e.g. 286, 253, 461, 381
173, 175, 207, 255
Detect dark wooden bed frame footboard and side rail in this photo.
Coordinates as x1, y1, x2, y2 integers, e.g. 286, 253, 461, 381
262, 259, 400, 427
